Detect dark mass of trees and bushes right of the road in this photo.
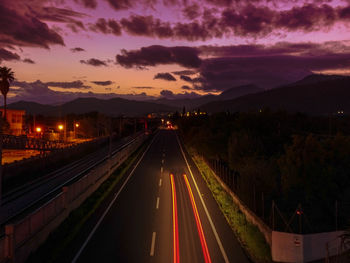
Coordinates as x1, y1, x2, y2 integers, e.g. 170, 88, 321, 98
173, 109, 350, 234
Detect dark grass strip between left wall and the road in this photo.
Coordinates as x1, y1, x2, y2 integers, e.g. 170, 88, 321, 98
27, 139, 150, 263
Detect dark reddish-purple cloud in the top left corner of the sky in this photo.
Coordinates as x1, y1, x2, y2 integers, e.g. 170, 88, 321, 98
0, 0, 64, 48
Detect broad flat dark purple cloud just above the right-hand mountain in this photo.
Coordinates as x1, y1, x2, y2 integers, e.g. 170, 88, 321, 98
196, 53, 350, 91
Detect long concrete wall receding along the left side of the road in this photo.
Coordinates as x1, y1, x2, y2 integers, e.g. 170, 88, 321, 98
0, 135, 146, 263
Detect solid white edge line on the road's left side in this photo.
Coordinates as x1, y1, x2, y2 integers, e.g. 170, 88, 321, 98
72, 136, 157, 263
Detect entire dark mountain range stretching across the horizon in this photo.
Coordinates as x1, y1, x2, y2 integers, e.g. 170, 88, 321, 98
8, 74, 350, 116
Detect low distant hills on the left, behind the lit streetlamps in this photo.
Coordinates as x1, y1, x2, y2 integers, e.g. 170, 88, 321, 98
8, 98, 179, 116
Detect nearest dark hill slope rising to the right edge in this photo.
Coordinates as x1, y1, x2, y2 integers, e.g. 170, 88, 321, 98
200, 76, 350, 115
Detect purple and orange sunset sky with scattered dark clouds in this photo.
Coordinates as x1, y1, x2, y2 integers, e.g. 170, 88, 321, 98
0, 0, 350, 103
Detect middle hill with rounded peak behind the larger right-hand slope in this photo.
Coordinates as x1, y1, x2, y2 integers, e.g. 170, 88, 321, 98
153, 85, 262, 109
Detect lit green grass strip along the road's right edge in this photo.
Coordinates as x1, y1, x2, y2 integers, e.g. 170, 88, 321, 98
187, 148, 272, 263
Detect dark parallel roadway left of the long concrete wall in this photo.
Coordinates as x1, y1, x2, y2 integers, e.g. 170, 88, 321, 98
0, 133, 142, 228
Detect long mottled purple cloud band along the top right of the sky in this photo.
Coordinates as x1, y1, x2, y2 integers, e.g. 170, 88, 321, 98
91, 1, 350, 41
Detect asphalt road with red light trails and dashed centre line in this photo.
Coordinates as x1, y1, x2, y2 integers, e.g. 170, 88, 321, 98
72, 130, 249, 263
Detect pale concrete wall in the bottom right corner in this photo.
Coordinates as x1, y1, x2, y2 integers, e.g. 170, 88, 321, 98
271, 231, 344, 262
